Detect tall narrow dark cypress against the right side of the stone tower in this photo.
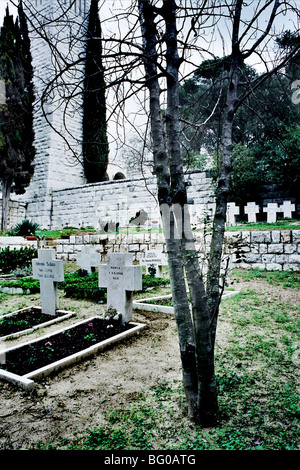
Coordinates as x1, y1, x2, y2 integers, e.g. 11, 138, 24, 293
82, 0, 109, 183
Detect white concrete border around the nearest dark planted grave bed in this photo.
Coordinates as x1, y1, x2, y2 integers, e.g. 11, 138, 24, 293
0, 316, 146, 390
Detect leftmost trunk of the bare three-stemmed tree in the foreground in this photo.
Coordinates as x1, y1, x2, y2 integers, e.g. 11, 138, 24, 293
139, 0, 197, 416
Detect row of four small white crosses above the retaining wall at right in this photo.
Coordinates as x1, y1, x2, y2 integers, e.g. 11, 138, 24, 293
227, 201, 295, 225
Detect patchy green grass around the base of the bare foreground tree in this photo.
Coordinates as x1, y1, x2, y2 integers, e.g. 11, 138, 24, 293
22, 270, 300, 450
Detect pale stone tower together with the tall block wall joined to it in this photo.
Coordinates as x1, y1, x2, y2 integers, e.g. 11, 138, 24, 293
0, 0, 213, 228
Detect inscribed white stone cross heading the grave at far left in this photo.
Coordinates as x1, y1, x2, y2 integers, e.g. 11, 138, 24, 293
32, 249, 64, 315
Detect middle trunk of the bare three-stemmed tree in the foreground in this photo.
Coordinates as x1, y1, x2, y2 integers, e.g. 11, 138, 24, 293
164, 0, 217, 425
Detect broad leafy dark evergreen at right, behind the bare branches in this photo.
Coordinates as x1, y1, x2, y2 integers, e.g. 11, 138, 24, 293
180, 58, 300, 206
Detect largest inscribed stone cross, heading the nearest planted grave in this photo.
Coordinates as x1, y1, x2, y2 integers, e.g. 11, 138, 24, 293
98, 253, 142, 324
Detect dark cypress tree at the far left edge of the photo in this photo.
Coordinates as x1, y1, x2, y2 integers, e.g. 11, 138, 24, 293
0, 1, 35, 230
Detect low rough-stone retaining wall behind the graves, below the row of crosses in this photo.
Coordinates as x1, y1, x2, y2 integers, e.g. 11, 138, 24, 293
49, 230, 300, 271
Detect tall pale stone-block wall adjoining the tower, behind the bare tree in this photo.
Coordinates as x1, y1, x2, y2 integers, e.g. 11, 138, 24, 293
51, 170, 214, 228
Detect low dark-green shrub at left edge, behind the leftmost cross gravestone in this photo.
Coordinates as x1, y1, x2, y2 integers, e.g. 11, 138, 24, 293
0, 246, 37, 274
